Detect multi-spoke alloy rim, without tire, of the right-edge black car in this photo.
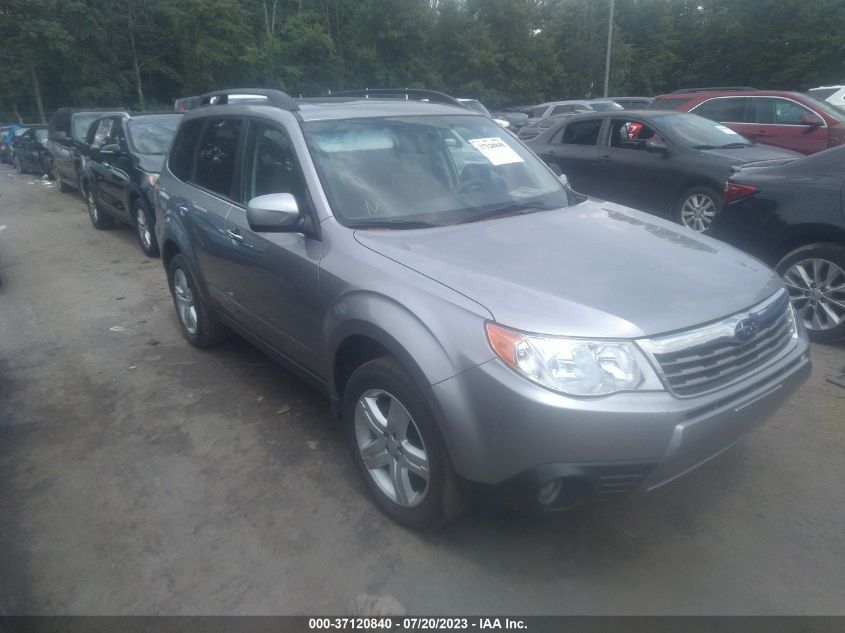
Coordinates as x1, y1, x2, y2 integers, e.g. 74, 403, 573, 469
783, 258, 845, 331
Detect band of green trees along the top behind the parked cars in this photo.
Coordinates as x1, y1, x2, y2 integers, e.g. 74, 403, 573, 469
0, 0, 845, 119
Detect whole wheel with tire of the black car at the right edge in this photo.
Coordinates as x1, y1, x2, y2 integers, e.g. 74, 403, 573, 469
777, 243, 845, 343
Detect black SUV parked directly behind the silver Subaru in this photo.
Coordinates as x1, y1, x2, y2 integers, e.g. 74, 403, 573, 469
82, 112, 182, 257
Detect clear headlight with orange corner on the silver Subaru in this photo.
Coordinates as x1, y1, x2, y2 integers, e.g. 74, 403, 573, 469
486, 322, 663, 396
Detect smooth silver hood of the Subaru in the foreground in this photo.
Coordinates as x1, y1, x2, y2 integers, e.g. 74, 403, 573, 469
355, 199, 782, 338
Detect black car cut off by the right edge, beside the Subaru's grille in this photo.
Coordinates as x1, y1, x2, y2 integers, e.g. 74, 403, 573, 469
712, 146, 845, 342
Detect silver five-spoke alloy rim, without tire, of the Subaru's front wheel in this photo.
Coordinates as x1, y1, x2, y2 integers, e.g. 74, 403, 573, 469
354, 389, 430, 507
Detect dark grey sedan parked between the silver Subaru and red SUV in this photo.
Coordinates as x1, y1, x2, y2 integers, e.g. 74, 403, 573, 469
527, 110, 801, 232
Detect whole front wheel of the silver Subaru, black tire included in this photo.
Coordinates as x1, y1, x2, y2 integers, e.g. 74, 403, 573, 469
343, 357, 464, 529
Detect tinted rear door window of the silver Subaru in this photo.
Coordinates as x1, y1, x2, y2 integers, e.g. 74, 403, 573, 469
194, 118, 243, 198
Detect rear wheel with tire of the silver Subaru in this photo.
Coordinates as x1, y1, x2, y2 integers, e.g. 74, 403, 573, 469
167, 255, 229, 347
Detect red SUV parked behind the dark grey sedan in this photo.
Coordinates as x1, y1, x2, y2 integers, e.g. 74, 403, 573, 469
649, 88, 845, 154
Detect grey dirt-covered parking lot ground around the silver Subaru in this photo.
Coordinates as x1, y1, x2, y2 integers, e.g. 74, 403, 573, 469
0, 166, 845, 614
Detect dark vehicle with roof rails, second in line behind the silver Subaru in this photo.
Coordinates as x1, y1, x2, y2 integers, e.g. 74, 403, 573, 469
47, 108, 126, 191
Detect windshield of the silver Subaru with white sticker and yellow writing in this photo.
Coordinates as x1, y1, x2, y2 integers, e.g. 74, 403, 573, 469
303, 115, 575, 228
